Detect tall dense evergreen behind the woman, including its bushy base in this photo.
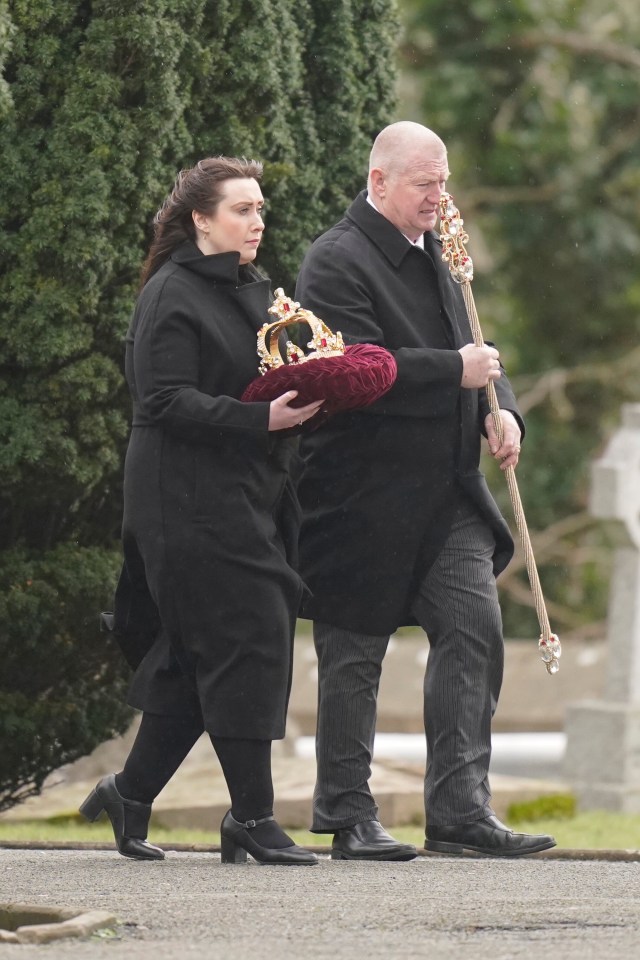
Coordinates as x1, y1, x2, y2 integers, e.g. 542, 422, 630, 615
0, 0, 396, 803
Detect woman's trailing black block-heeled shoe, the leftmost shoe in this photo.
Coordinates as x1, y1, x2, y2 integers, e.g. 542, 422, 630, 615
80, 773, 164, 860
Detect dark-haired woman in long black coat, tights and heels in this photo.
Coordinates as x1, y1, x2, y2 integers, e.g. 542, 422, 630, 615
81, 157, 320, 864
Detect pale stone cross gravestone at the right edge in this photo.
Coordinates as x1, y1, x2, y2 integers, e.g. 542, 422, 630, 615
565, 403, 640, 813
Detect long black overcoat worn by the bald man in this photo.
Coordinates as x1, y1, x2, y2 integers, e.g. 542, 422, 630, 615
296, 193, 519, 635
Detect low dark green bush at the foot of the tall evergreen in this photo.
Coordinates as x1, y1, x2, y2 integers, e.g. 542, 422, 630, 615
0, 544, 131, 811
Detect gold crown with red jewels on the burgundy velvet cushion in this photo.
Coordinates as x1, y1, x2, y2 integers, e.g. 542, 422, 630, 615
258, 287, 344, 374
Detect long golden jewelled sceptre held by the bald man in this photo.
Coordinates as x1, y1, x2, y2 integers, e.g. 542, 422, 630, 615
440, 193, 562, 674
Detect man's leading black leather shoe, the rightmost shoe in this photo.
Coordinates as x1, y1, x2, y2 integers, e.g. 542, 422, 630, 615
425, 815, 556, 857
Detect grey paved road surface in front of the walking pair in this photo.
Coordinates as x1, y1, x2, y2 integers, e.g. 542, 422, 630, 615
0, 849, 640, 960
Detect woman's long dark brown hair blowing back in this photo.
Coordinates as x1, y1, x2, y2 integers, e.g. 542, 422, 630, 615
140, 157, 262, 287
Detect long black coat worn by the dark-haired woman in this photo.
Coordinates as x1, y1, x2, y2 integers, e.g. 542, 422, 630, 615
116, 243, 302, 739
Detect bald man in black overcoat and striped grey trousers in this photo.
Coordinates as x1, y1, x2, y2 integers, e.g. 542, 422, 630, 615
296, 122, 555, 860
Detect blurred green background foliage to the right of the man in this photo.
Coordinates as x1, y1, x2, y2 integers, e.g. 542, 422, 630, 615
403, 0, 640, 636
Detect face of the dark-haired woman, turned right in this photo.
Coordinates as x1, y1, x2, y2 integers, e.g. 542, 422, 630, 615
193, 177, 264, 263
